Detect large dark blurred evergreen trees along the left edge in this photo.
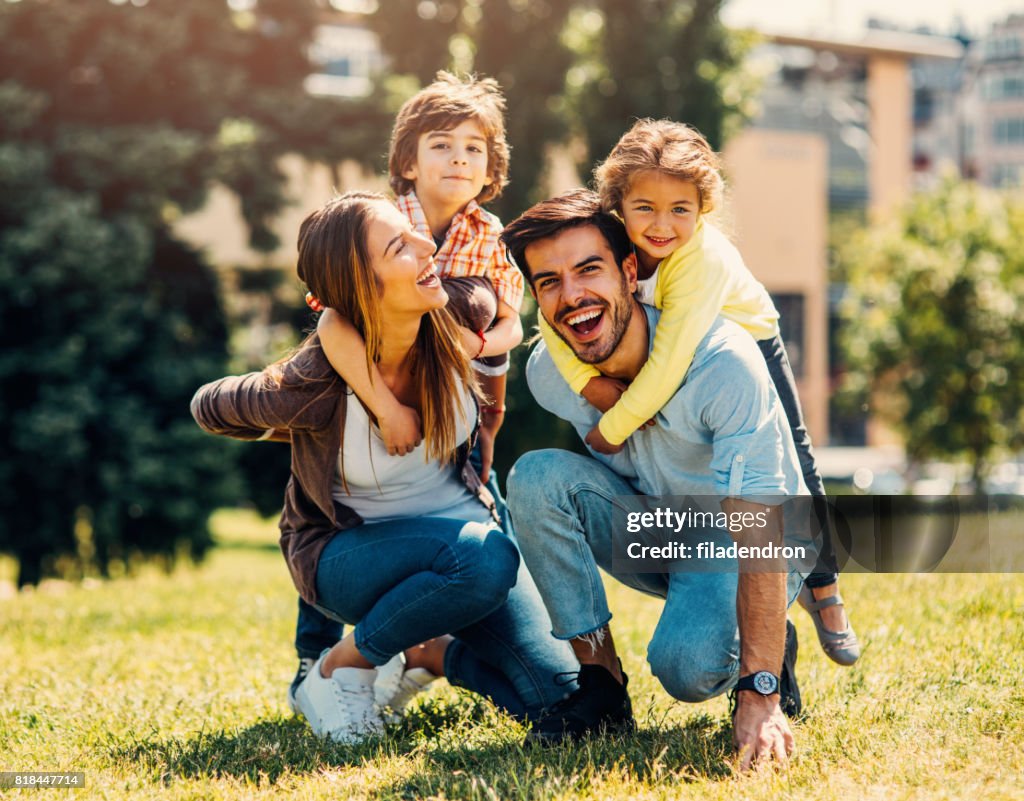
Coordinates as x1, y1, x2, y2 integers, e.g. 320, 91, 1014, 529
0, 0, 386, 584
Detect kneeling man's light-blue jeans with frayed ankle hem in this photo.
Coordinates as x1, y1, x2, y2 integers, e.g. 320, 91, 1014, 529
508, 450, 799, 702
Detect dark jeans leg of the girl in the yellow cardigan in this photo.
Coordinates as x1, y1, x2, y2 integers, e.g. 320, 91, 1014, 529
758, 337, 839, 587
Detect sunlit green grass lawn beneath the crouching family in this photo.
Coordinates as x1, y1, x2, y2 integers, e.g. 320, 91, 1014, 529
0, 512, 1024, 801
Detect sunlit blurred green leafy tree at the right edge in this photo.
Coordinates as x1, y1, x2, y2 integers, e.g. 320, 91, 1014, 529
840, 177, 1024, 488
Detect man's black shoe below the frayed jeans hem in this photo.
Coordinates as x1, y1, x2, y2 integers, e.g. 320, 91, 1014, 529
526, 665, 636, 745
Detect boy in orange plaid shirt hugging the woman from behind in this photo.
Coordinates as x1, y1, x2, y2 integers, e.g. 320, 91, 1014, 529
289, 72, 523, 712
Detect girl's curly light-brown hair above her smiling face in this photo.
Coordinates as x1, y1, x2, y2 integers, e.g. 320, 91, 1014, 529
594, 118, 722, 214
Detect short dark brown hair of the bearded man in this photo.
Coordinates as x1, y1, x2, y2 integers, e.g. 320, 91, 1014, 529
502, 189, 631, 284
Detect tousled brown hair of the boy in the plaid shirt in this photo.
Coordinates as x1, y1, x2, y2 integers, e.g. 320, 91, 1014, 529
387, 70, 509, 204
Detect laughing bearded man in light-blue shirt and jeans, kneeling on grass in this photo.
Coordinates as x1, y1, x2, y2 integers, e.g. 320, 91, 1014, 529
502, 189, 807, 768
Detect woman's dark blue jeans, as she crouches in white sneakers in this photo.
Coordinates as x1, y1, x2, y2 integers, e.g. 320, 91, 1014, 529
316, 517, 579, 718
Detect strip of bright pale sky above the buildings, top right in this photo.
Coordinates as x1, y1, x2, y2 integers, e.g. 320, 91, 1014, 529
722, 0, 1024, 37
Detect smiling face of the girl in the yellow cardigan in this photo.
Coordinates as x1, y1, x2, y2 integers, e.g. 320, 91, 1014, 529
623, 170, 700, 261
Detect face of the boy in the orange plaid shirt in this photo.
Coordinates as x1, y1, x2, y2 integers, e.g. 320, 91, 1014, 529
402, 120, 494, 209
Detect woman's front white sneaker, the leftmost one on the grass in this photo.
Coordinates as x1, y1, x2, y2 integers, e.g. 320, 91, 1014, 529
295, 650, 384, 744
